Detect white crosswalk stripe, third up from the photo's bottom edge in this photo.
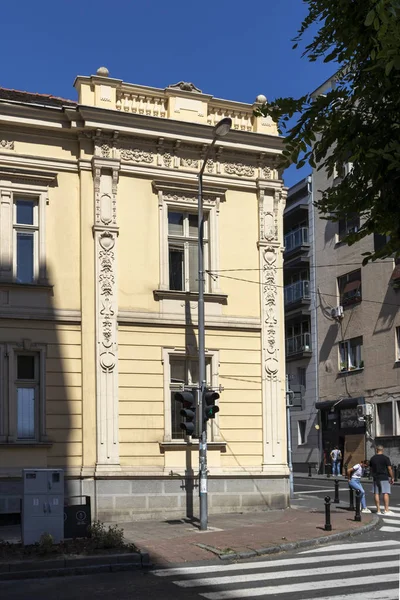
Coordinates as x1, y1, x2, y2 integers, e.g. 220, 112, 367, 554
174, 552, 399, 588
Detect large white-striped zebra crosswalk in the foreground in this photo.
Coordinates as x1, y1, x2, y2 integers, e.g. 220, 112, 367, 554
153, 536, 400, 600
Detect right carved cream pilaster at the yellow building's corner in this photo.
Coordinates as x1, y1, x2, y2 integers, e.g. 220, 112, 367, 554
258, 182, 287, 475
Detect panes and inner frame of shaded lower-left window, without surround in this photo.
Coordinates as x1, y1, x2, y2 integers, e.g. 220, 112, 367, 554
15, 354, 39, 440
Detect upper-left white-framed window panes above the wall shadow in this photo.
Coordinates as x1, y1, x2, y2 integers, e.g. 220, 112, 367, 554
13, 195, 39, 283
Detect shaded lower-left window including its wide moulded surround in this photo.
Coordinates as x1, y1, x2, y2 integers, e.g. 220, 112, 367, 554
0, 344, 47, 443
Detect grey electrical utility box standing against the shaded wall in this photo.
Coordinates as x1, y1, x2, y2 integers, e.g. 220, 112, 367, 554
21, 469, 64, 546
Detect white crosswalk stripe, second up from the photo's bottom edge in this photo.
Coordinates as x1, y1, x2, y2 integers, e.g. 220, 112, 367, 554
200, 563, 399, 600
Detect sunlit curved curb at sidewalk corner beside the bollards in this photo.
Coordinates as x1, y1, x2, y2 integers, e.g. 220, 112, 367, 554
196, 515, 380, 560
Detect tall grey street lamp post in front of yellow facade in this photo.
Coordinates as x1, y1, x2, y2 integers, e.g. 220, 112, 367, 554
197, 117, 232, 531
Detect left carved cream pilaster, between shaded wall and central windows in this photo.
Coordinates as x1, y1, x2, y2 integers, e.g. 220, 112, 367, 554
93, 157, 119, 470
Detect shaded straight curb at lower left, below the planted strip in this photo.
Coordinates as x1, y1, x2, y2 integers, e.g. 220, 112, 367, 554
0, 552, 150, 581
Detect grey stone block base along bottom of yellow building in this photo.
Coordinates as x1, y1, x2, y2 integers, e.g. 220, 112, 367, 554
0, 477, 289, 522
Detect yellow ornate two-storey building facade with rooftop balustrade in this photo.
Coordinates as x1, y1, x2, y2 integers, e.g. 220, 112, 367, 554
0, 68, 288, 521
